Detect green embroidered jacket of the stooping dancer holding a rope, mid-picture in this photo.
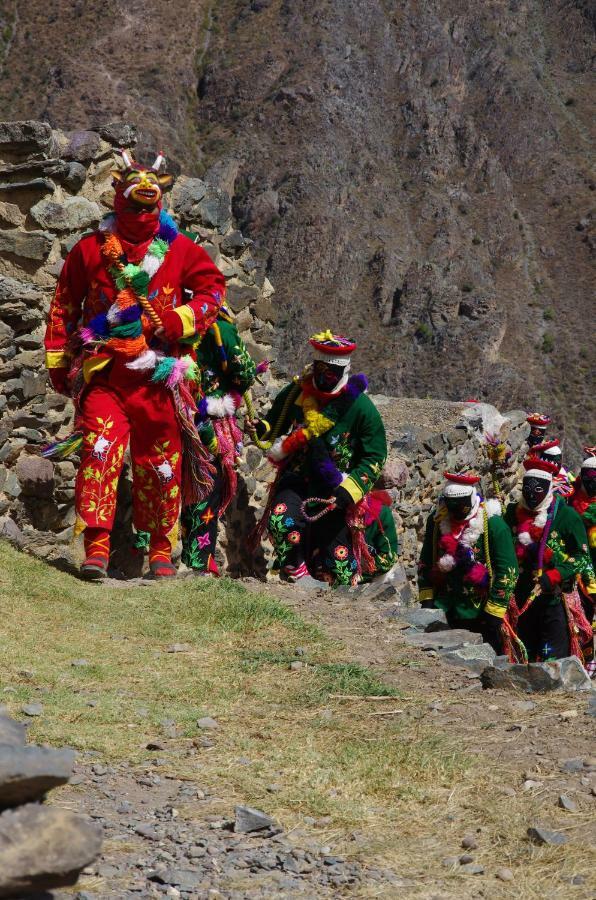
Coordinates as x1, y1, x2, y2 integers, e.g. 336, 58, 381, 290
261, 382, 387, 503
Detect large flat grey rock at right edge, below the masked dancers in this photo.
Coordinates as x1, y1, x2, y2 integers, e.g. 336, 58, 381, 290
481, 656, 593, 693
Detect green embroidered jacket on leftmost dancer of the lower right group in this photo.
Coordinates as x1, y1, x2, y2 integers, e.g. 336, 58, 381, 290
418, 510, 517, 619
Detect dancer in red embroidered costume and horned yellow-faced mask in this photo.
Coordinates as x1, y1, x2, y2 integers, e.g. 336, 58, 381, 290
44, 151, 225, 578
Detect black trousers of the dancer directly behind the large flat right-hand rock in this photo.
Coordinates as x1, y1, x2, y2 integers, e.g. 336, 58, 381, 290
517, 594, 569, 662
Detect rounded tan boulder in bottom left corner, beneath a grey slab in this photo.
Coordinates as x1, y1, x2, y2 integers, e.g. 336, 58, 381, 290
0, 803, 102, 898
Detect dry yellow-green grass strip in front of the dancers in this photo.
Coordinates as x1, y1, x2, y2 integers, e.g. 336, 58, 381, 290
0, 547, 593, 900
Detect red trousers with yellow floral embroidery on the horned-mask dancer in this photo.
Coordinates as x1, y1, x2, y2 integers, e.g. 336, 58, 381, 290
75, 360, 182, 546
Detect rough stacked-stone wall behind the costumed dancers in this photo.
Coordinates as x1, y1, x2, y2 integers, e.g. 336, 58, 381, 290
0, 122, 527, 579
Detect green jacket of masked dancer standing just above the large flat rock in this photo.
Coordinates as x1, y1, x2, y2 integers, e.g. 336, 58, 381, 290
505, 495, 593, 606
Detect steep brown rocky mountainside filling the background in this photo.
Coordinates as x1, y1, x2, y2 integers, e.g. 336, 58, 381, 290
0, 0, 596, 446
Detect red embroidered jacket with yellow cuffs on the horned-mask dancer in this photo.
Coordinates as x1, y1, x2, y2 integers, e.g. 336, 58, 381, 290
45, 232, 225, 369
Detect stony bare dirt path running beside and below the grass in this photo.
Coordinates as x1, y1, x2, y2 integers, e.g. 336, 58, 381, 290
55, 579, 596, 900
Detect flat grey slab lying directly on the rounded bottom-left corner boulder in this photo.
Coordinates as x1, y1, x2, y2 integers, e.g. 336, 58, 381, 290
0, 744, 75, 809
